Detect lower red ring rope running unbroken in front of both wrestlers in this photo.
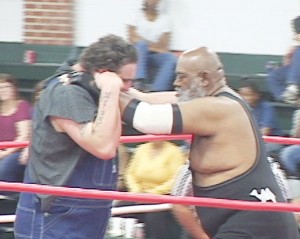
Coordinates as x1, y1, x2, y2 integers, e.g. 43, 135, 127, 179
0, 182, 300, 212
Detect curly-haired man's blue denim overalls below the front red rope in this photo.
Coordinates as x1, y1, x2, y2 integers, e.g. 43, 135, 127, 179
15, 193, 111, 239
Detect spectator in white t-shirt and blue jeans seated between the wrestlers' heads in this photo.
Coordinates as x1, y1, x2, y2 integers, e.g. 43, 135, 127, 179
128, 0, 177, 91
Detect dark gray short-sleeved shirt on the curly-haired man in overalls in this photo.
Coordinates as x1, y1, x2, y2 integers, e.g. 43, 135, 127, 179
28, 82, 97, 186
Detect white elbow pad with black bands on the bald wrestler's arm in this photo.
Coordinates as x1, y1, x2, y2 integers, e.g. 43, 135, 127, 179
123, 100, 182, 134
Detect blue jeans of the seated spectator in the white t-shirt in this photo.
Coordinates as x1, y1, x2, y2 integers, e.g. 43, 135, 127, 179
135, 41, 177, 91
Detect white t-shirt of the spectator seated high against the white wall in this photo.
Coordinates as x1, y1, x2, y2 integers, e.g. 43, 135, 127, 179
128, 11, 171, 42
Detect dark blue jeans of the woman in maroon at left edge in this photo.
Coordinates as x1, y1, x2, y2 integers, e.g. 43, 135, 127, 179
0, 151, 25, 182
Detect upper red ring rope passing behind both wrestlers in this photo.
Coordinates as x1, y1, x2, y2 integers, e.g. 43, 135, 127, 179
0, 134, 300, 149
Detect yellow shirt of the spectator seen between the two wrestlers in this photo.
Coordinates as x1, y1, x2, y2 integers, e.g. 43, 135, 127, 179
125, 141, 185, 194
